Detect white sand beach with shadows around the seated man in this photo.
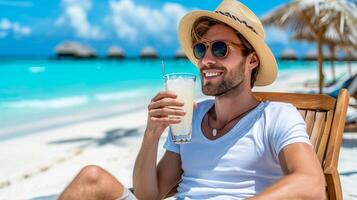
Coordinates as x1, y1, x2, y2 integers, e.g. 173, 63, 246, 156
0, 63, 357, 200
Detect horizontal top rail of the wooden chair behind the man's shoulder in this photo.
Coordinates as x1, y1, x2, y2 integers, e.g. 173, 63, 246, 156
254, 92, 336, 110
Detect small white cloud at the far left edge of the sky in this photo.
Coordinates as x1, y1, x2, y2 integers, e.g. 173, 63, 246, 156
0, 18, 32, 38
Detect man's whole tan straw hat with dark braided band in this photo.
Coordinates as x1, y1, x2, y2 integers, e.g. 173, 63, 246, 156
179, 0, 277, 86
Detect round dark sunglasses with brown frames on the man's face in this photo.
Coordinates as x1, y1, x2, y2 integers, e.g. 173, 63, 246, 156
192, 40, 243, 60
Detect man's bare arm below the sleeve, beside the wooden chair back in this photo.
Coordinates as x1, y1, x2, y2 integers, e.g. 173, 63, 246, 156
251, 143, 326, 200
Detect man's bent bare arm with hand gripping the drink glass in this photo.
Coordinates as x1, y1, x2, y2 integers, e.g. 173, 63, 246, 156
133, 92, 185, 199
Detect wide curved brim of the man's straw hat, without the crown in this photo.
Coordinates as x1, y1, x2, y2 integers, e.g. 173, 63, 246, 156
179, 11, 278, 86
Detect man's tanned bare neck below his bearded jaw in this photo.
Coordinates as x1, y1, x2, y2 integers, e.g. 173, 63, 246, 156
214, 88, 259, 124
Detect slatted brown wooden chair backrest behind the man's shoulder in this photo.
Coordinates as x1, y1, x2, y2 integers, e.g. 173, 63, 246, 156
254, 89, 349, 199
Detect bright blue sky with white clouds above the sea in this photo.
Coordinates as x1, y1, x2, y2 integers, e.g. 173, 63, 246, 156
0, 0, 313, 56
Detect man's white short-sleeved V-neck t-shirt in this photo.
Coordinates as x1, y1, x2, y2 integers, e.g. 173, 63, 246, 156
164, 100, 311, 200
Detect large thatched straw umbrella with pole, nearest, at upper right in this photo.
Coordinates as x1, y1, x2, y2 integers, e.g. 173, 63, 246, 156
262, 0, 357, 93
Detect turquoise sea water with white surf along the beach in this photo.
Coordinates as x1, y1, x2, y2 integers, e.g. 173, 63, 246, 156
0, 59, 348, 138
